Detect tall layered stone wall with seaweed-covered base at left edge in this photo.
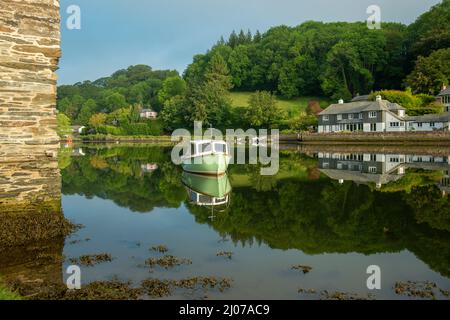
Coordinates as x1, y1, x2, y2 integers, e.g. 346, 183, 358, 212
0, 0, 66, 252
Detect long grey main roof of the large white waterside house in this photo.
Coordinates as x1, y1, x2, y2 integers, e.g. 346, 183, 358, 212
320, 100, 406, 115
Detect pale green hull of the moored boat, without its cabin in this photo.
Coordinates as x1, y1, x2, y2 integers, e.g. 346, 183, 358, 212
182, 153, 231, 176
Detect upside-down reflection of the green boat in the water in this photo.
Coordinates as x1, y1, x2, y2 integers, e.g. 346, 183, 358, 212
182, 172, 231, 206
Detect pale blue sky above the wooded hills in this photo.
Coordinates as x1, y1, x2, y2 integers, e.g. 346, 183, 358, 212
57, 0, 440, 84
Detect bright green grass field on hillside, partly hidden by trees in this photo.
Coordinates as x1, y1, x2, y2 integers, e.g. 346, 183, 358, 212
231, 92, 331, 116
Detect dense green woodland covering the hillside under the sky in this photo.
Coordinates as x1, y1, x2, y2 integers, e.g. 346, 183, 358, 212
58, 0, 450, 135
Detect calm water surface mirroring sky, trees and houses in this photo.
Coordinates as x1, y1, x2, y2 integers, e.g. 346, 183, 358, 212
60, 146, 450, 299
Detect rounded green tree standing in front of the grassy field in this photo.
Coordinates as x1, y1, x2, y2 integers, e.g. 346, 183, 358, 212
245, 91, 281, 129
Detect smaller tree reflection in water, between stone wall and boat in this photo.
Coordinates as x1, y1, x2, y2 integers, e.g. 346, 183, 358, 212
62, 147, 186, 212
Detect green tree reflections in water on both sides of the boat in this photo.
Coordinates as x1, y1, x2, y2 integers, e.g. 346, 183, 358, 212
62, 147, 450, 275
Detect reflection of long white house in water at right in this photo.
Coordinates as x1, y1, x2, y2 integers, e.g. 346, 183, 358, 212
318, 152, 450, 191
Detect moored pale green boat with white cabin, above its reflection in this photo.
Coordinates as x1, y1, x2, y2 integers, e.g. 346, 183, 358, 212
182, 140, 231, 175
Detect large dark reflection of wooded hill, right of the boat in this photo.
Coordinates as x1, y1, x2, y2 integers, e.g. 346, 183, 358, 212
189, 180, 450, 276
